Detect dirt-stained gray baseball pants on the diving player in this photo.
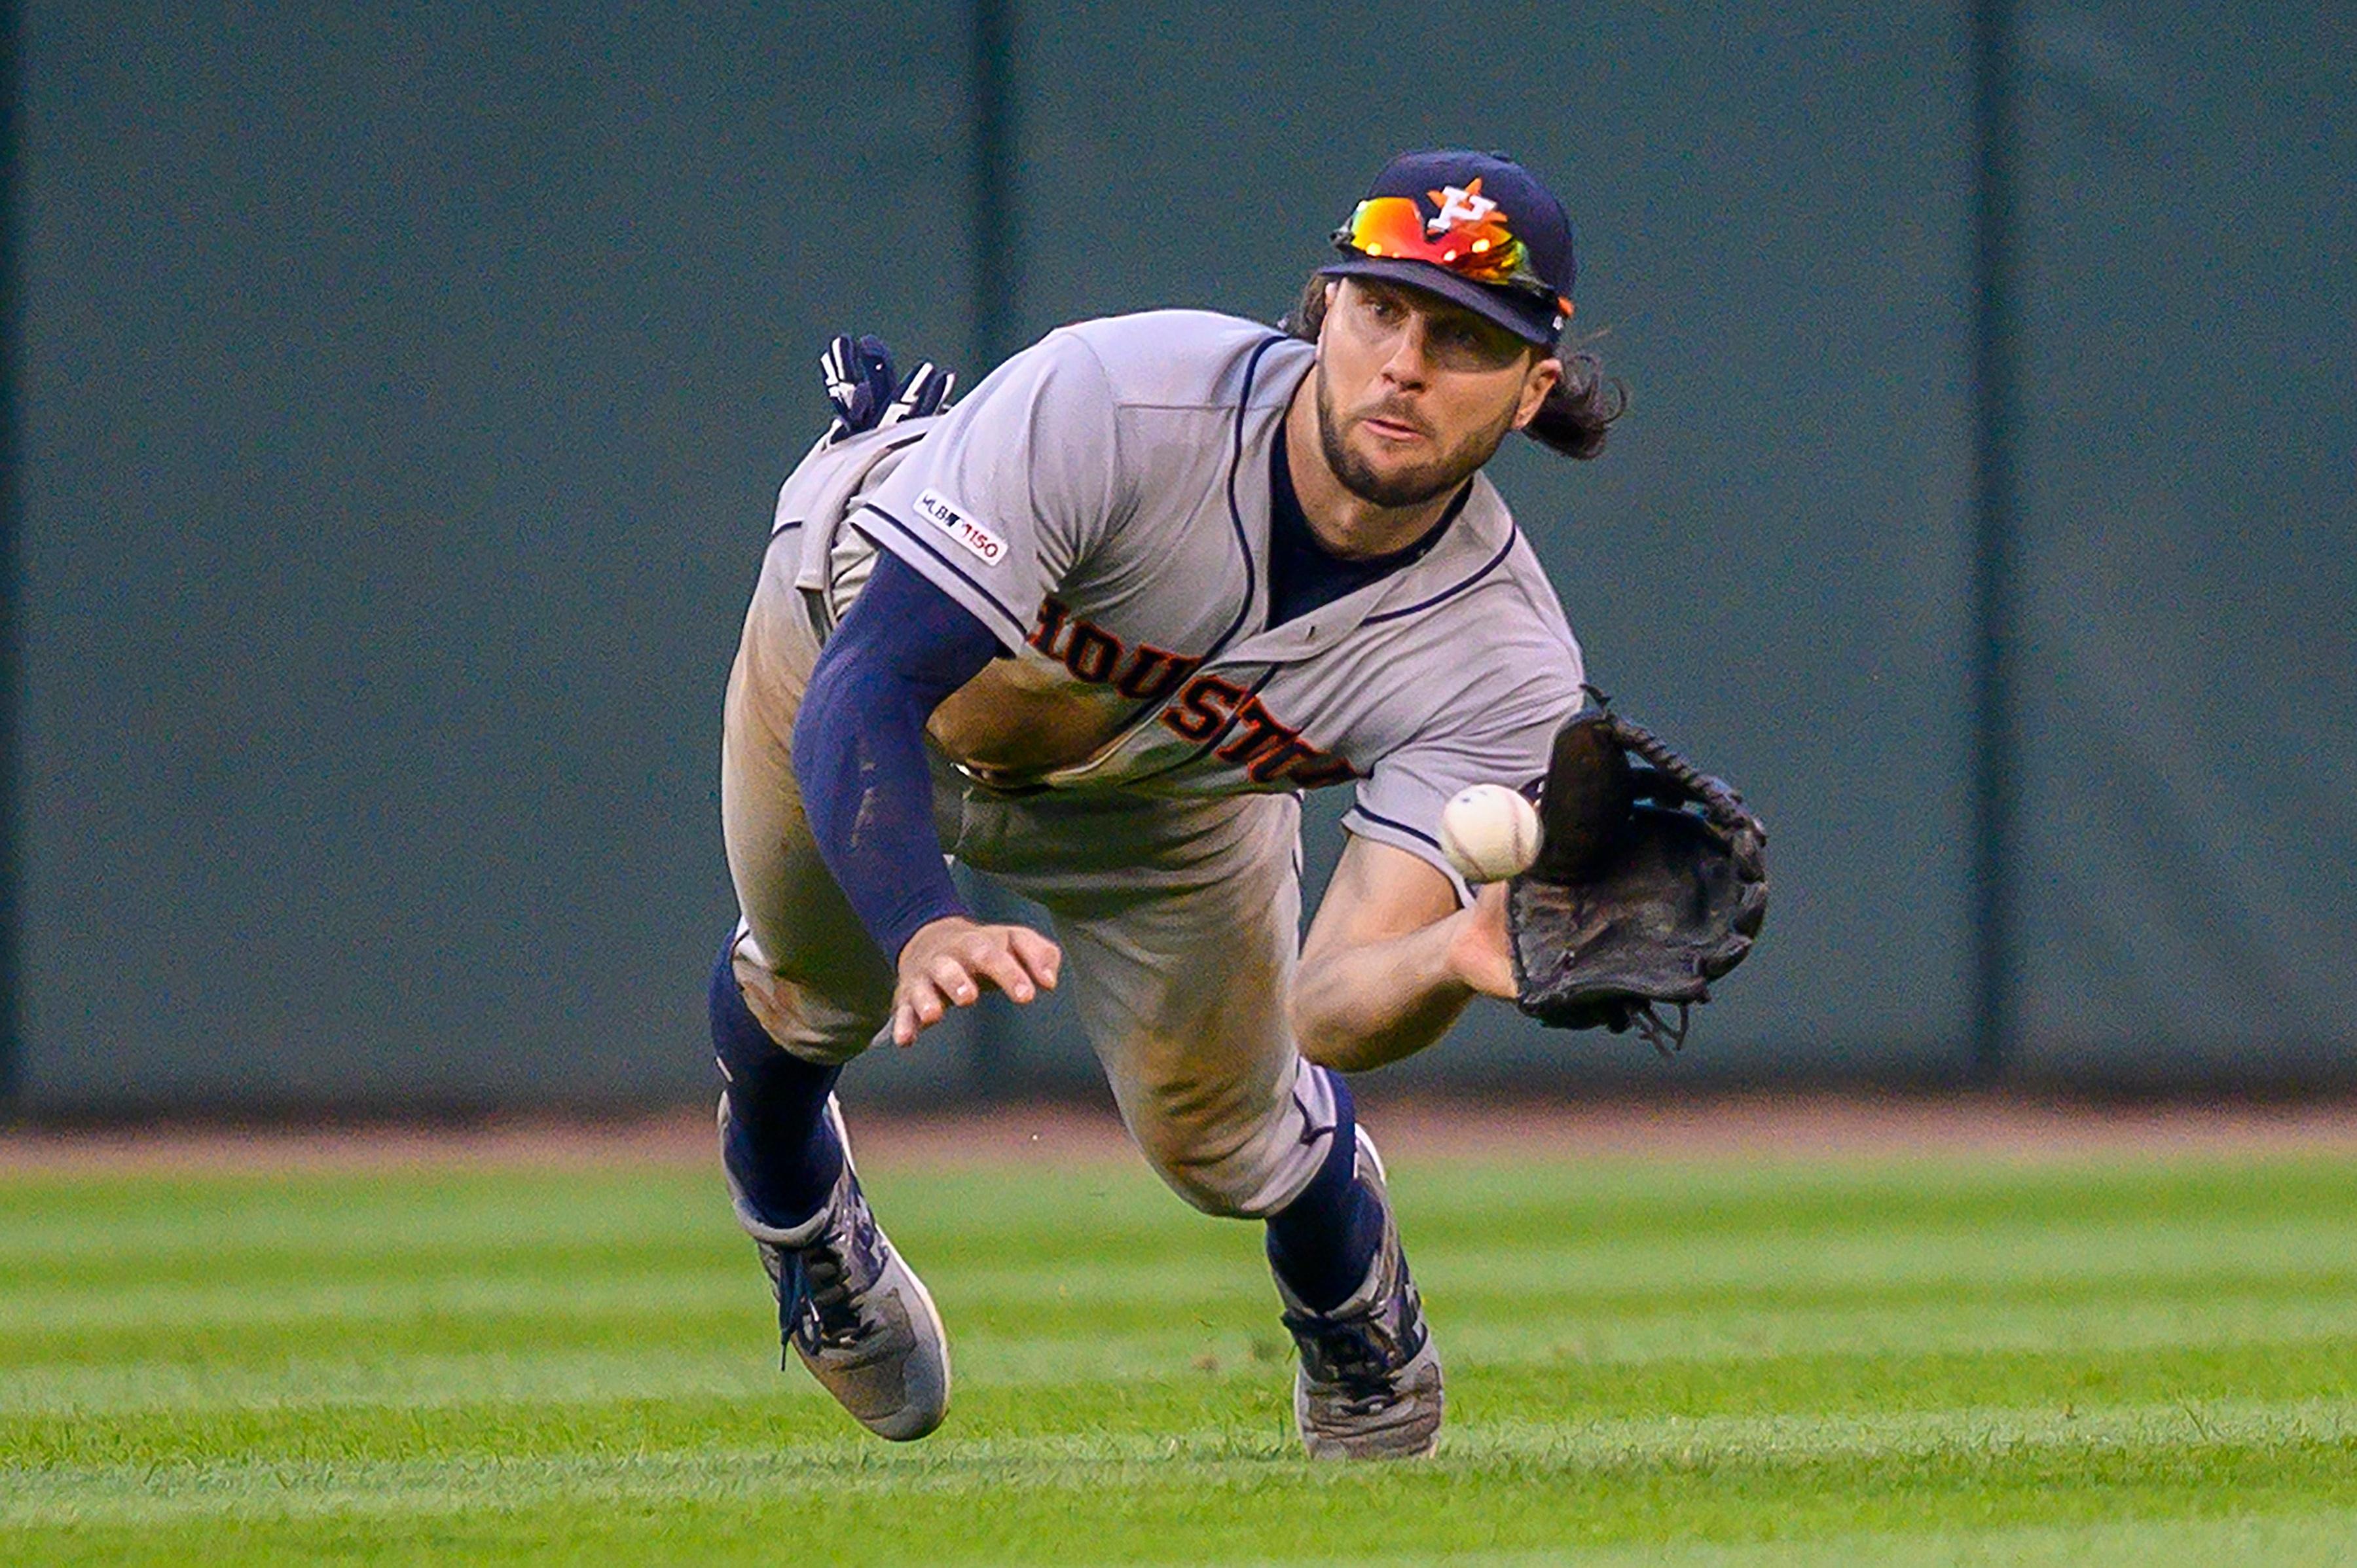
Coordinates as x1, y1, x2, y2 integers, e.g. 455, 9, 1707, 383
722, 536, 1334, 1216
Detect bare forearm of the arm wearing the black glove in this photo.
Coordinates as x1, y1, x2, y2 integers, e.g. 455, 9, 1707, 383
1292, 910, 1476, 1073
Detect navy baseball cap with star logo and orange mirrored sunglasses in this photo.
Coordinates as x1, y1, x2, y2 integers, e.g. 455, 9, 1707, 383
1317, 146, 1579, 349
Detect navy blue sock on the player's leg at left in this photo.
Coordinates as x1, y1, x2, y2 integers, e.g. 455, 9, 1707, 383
710, 938, 844, 1228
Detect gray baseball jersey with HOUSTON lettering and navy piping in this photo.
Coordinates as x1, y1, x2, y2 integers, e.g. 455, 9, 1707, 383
778, 311, 1582, 898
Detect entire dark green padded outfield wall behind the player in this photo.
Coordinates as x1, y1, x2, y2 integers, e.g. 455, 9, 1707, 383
19, 3, 2357, 1108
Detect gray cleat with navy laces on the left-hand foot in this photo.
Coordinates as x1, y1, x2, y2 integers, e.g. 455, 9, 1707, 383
722, 1094, 950, 1443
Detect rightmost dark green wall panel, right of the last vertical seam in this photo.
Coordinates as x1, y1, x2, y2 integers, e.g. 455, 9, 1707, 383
2022, 0, 2357, 1078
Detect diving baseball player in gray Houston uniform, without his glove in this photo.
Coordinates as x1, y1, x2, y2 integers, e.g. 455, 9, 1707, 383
712, 151, 1619, 1457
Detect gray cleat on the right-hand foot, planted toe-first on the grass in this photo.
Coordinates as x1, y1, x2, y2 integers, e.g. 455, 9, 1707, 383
1277, 1132, 1442, 1459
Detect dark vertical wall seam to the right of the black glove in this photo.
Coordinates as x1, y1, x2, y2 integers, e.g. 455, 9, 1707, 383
1971, 0, 2018, 1082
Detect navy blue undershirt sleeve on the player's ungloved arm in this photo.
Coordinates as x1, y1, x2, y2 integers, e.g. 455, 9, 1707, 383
794, 549, 999, 962
